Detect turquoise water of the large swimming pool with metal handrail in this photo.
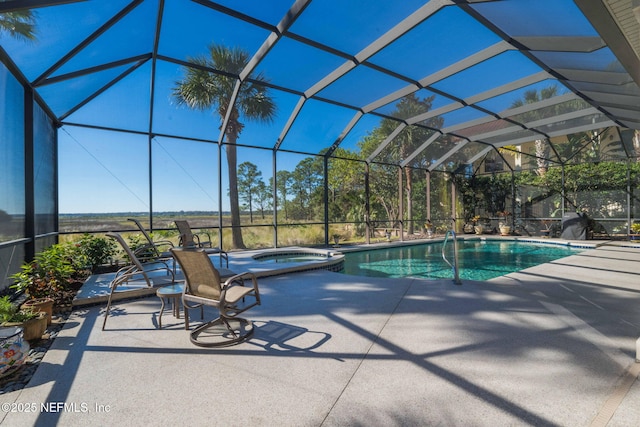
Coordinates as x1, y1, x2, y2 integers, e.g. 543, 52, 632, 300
343, 240, 584, 280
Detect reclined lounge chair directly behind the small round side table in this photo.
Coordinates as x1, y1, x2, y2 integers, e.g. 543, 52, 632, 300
102, 232, 176, 331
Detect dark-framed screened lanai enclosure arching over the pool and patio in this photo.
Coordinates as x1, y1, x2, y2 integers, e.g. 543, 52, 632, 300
0, 0, 640, 286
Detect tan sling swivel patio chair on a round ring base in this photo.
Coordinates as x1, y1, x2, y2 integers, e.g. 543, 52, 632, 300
170, 248, 260, 347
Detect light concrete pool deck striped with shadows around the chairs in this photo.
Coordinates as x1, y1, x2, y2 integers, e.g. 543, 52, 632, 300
0, 242, 640, 426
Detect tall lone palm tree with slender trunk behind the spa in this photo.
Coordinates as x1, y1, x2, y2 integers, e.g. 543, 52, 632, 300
173, 44, 276, 249
